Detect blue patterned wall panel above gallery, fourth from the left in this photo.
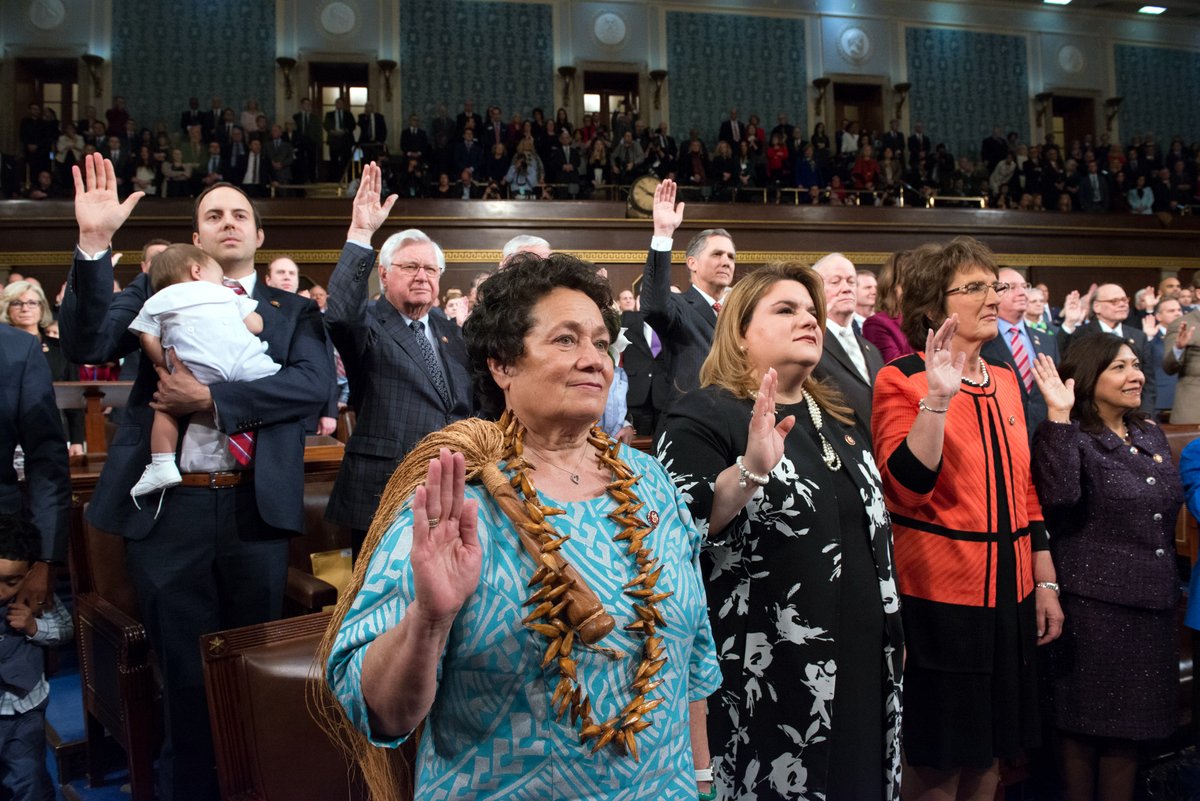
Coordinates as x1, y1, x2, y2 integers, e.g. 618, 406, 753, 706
905, 28, 1030, 159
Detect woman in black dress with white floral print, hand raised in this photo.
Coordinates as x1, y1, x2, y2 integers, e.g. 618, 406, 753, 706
655, 253, 902, 801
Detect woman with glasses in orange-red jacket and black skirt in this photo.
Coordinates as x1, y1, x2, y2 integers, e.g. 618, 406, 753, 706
871, 237, 1063, 801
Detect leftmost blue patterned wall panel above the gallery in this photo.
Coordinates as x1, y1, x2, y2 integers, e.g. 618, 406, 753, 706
112, 0, 276, 132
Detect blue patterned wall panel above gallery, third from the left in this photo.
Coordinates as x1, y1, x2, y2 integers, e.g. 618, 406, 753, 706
667, 11, 809, 146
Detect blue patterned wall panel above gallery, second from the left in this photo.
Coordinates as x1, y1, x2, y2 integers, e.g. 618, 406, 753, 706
400, 0, 562, 126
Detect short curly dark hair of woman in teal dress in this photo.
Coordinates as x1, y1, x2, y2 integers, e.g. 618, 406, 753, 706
462, 253, 620, 417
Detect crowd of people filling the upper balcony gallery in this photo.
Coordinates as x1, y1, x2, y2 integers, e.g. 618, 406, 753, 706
5, 97, 1200, 215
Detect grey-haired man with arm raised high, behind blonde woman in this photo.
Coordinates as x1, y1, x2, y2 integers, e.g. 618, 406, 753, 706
641, 179, 737, 422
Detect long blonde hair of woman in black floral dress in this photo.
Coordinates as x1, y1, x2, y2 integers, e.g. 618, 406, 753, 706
700, 261, 854, 426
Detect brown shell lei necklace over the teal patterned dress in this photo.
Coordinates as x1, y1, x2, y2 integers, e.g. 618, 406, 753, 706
499, 411, 672, 761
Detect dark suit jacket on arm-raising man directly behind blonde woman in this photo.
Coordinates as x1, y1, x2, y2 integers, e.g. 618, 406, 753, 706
642, 249, 716, 408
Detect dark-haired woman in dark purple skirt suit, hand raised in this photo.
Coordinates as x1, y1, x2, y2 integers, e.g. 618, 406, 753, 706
1033, 333, 1183, 801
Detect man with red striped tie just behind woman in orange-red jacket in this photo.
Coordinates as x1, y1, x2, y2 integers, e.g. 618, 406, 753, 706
980, 267, 1058, 444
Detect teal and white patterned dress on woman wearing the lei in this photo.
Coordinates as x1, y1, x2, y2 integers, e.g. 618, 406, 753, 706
326, 447, 721, 801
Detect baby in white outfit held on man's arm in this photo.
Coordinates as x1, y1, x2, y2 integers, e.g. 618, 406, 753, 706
130, 245, 280, 504
